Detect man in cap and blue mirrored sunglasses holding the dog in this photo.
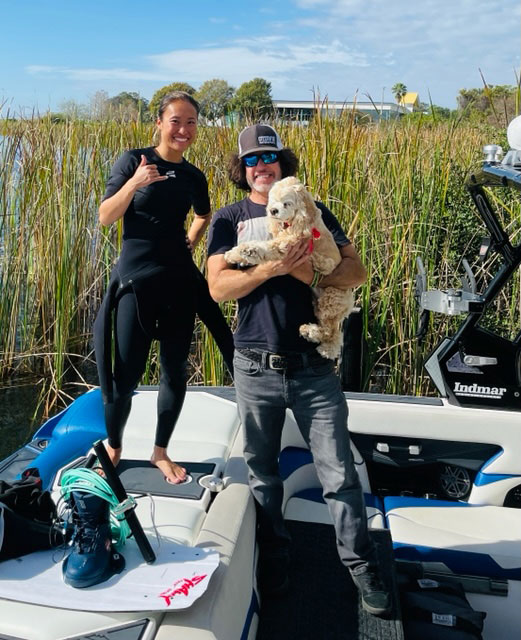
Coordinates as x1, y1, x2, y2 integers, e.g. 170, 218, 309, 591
208, 125, 390, 615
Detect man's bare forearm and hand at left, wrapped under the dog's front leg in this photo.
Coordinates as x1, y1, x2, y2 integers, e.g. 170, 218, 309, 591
207, 240, 309, 302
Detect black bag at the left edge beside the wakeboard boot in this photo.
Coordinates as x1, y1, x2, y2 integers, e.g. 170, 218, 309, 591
0, 469, 63, 561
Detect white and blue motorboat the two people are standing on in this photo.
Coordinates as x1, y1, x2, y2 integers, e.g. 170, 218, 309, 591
0, 138, 521, 640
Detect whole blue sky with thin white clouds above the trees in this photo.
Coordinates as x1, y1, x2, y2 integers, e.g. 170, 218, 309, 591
0, 0, 521, 114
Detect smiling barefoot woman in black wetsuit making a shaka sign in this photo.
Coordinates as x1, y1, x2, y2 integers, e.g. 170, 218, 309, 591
94, 91, 233, 483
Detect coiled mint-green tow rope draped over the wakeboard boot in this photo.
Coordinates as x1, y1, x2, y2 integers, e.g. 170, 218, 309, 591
61, 469, 136, 548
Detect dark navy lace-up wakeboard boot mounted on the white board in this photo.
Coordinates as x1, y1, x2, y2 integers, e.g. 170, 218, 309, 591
62, 491, 125, 589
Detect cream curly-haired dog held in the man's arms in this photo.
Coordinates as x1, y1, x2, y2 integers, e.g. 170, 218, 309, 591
224, 177, 354, 360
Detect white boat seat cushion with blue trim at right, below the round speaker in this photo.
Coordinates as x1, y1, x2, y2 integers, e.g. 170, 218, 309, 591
384, 497, 521, 580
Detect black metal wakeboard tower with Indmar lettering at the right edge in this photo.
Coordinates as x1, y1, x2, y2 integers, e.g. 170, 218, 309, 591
416, 125, 521, 411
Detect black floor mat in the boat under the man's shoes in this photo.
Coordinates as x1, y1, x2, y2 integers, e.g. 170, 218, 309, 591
256, 521, 404, 640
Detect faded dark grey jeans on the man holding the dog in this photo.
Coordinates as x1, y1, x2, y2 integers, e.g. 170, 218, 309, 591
234, 351, 374, 569
